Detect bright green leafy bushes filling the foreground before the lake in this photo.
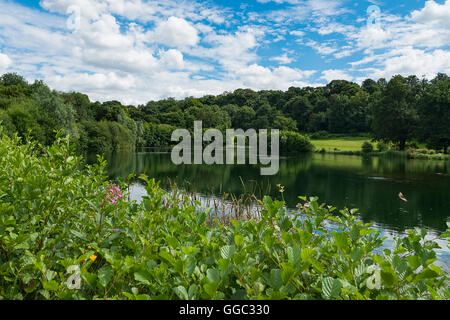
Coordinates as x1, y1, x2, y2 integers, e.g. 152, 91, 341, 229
0, 129, 450, 300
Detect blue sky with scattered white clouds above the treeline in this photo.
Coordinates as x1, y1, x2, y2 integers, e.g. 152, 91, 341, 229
0, 0, 450, 105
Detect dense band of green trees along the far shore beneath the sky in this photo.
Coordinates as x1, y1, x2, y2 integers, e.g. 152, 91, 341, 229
0, 73, 450, 153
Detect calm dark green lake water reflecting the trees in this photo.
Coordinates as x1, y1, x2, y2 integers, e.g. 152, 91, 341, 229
93, 151, 450, 270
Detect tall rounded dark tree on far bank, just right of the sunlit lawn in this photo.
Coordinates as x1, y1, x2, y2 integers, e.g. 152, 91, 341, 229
373, 75, 418, 150
